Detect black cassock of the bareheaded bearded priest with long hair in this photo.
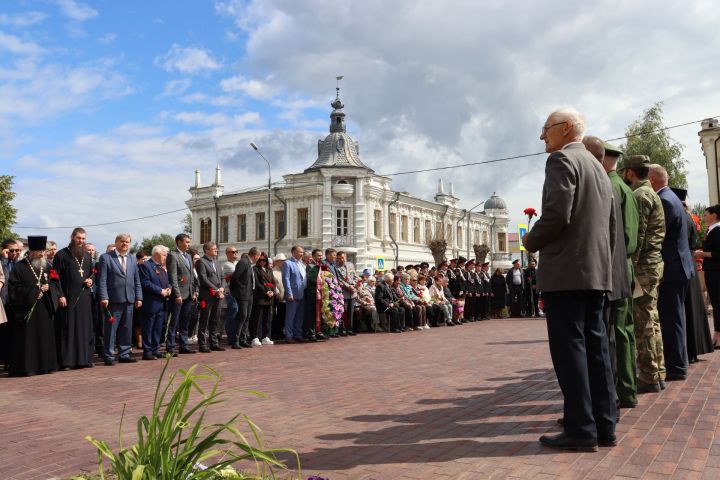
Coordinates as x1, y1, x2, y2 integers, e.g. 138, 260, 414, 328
53, 247, 95, 368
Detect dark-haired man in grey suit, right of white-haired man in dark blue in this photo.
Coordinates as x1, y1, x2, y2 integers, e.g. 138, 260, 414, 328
165, 233, 198, 354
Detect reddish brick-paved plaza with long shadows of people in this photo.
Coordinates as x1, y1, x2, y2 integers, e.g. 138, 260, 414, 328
0, 320, 720, 480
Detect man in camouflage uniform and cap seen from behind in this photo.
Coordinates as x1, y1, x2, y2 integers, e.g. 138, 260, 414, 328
621, 155, 665, 393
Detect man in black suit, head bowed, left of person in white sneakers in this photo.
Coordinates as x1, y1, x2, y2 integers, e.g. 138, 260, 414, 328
226, 247, 260, 348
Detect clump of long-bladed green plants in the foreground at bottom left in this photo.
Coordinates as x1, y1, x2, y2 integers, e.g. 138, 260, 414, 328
85, 358, 300, 480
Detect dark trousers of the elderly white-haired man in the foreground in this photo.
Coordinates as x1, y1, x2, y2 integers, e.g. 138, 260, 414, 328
543, 290, 617, 439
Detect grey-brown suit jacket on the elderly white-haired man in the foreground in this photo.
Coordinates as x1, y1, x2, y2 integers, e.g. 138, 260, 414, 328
525, 142, 616, 292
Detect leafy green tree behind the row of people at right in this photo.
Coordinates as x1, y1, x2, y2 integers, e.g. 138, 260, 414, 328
621, 102, 687, 188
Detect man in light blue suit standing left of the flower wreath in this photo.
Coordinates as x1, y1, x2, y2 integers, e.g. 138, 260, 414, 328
282, 245, 307, 343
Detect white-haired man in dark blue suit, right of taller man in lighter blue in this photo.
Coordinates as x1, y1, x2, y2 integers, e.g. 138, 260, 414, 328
140, 245, 172, 360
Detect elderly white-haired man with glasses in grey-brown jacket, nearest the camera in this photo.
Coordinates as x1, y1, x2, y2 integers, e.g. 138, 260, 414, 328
523, 109, 617, 451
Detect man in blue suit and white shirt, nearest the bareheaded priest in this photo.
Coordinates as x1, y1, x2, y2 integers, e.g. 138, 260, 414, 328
97, 233, 142, 366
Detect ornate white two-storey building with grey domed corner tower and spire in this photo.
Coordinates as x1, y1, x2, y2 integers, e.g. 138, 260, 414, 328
186, 88, 510, 268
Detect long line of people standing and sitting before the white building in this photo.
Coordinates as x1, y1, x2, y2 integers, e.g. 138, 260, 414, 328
0, 231, 540, 376
